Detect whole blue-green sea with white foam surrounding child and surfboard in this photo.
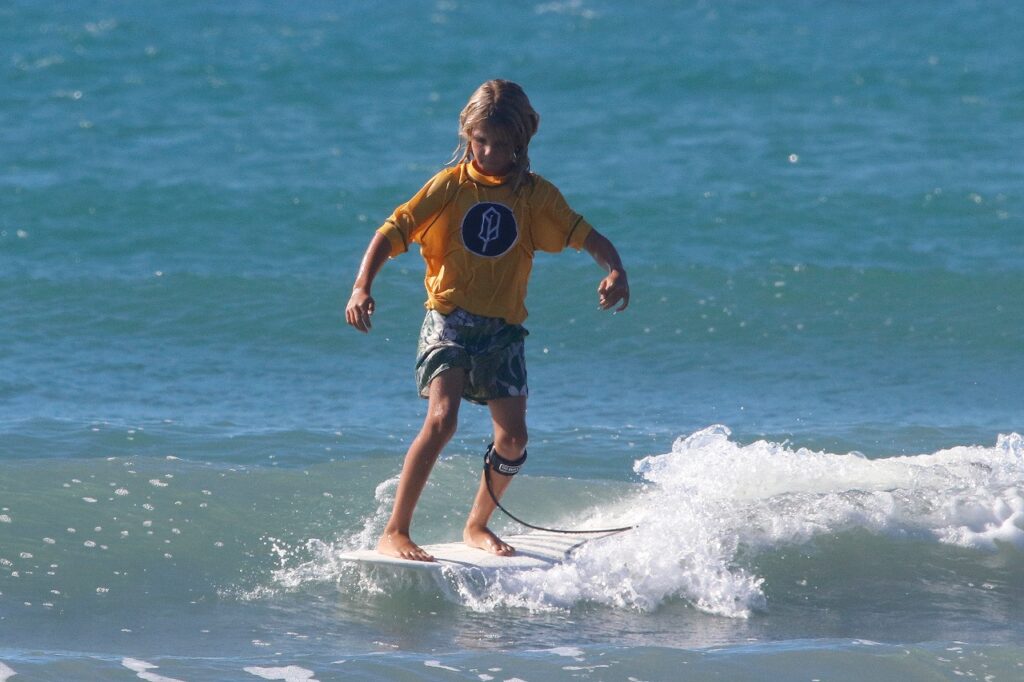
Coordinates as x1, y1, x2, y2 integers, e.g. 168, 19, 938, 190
0, 0, 1024, 681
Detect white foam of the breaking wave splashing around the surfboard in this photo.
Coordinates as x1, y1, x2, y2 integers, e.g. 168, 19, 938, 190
276, 426, 1024, 617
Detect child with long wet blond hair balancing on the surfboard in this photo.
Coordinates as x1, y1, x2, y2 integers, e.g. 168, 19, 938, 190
345, 80, 630, 561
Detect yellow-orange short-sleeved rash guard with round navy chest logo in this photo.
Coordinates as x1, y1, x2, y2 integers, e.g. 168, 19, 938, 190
377, 163, 592, 325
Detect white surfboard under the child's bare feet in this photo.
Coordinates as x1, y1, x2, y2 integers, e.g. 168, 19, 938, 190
338, 531, 605, 571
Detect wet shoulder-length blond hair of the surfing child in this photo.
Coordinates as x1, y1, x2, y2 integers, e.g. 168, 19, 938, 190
452, 79, 541, 191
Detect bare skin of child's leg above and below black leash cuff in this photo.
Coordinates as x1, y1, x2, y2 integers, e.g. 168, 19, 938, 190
462, 395, 526, 556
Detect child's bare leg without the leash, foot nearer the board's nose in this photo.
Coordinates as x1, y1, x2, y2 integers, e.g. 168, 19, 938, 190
377, 369, 466, 561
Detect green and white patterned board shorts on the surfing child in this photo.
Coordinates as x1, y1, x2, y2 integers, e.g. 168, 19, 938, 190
416, 308, 529, 404
